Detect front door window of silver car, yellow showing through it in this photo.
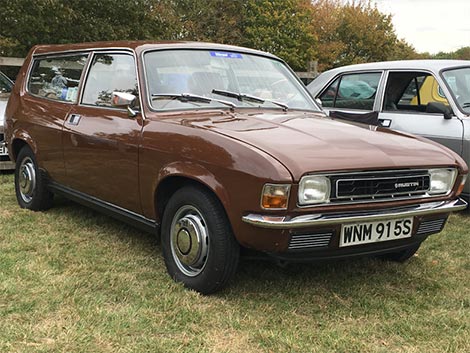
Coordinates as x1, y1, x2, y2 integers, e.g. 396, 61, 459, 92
383, 71, 449, 113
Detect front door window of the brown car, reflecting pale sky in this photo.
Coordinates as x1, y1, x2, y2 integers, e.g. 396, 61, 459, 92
82, 54, 139, 107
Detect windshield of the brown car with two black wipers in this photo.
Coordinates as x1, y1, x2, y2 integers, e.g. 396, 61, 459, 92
144, 50, 320, 111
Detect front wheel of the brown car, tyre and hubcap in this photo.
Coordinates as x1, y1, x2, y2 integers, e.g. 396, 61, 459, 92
161, 186, 240, 294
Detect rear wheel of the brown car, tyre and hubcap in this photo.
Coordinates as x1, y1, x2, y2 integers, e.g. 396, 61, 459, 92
15, 146, 53, 211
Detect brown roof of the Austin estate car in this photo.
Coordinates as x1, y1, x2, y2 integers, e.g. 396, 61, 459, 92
32, 41, 280, 60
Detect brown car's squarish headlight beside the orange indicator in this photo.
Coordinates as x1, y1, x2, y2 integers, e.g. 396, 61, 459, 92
299, 175, 331, 205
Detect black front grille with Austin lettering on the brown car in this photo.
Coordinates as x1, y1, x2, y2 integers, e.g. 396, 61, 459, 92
330, 170, 430, 203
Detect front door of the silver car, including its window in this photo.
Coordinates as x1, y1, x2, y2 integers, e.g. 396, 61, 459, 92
379, 71, 463, 155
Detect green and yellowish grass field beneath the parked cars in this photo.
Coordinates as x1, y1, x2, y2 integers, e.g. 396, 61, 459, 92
0, 174, 470, 353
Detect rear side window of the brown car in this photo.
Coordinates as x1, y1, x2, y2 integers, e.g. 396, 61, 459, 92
28, 54, 88, 102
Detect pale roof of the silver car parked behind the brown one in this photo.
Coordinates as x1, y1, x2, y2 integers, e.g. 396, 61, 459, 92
308, 59, 470, 95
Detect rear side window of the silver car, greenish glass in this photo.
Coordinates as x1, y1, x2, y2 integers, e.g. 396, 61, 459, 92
319, 72, 382, 110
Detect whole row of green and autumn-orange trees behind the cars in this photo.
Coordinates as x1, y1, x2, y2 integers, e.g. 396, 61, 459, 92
6, 0, 462, 71
